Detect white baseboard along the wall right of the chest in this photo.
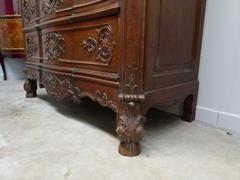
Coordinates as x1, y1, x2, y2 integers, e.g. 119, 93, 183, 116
196, 106, 240, 133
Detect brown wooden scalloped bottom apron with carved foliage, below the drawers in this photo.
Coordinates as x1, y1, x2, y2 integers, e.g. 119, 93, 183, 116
41, 71, 117, 111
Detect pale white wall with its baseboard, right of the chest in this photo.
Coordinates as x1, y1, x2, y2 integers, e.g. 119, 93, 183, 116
196, 0, 240, 132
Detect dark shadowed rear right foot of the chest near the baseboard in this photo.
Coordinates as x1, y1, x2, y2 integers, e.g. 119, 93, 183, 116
182, 95, 197, 122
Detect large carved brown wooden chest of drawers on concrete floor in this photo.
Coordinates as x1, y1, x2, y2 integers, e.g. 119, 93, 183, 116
22, 0, 205, 156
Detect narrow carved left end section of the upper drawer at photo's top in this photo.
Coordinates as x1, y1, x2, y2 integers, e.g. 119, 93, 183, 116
21, 0, 37, 27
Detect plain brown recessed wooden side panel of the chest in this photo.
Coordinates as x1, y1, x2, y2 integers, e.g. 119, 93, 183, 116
145, 0, 205, 89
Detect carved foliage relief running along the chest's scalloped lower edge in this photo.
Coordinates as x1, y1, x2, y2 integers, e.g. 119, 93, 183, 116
43, 74, 117, 112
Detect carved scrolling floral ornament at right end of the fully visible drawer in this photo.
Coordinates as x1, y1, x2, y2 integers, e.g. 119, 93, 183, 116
82, 25, 115, 64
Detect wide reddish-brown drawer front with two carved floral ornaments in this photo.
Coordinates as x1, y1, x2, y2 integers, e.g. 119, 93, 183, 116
42, 17, 119, 72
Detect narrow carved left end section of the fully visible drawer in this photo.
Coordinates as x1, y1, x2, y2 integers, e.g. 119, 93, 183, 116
25, 32, 41, 62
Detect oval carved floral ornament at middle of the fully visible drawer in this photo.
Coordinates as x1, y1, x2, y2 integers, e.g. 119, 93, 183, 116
44, 32, 65, 60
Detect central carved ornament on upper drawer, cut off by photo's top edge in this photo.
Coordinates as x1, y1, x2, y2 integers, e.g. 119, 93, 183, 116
42, 0, 63, 15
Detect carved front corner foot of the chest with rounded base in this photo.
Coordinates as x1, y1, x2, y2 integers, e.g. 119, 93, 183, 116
116, 104, 145, 156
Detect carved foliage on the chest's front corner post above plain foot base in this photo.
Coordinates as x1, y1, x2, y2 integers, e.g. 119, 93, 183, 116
116, 65, 145, 144
